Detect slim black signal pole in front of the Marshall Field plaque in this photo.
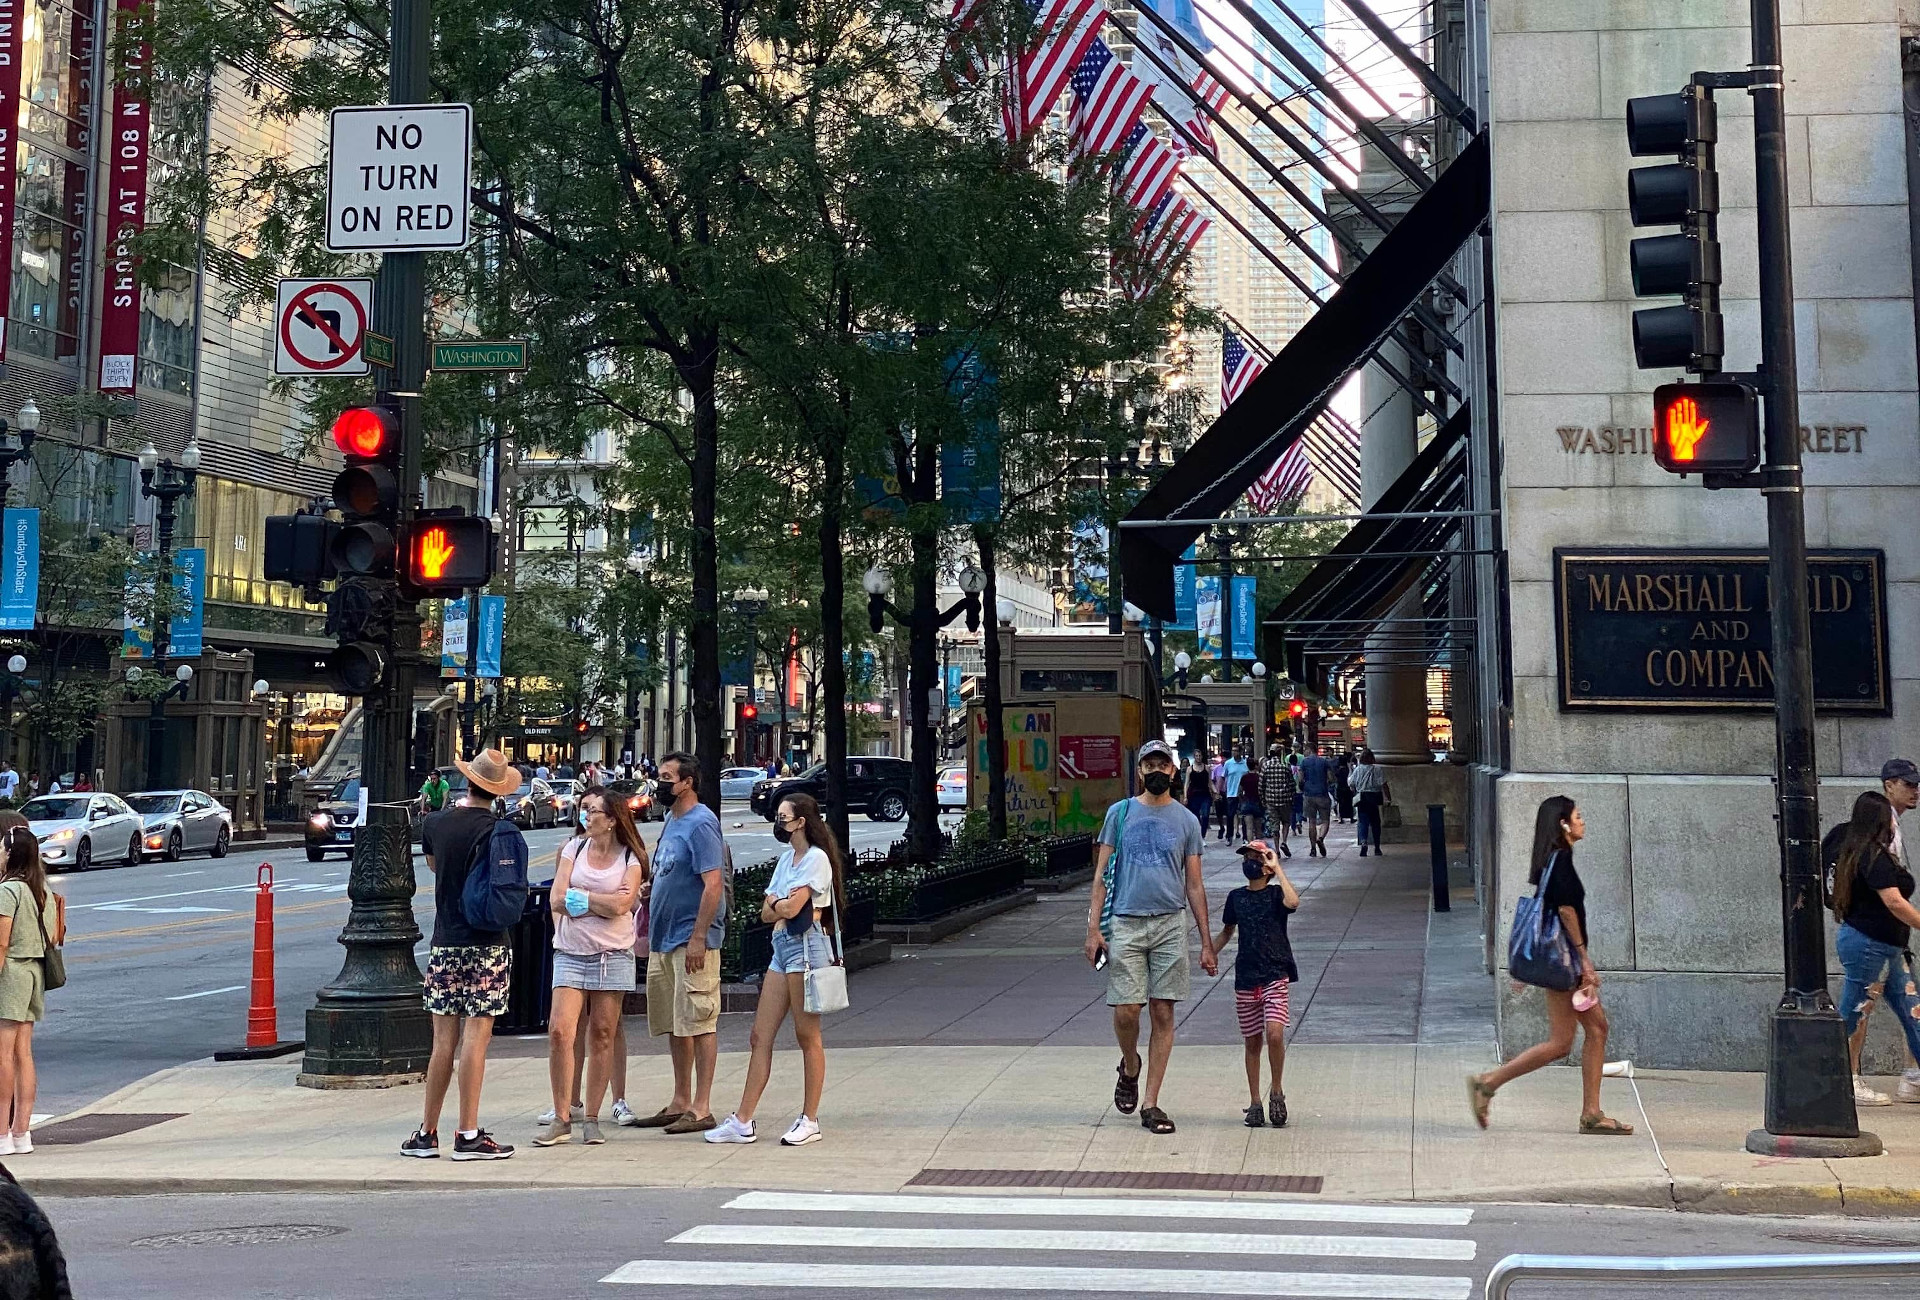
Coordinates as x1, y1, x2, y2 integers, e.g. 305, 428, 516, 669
1747, 0, 1880, 1156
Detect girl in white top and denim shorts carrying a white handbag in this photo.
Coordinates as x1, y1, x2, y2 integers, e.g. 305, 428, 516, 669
707, 795, 841, 1146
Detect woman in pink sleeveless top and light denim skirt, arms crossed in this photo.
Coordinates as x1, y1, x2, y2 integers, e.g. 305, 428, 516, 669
534, 789, 647, 1146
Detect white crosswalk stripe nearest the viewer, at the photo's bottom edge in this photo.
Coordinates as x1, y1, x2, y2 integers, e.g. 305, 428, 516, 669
601, 1260, 1473, 1300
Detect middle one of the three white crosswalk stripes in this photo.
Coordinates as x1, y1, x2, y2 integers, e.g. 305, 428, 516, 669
668, 1223, 1475, 1260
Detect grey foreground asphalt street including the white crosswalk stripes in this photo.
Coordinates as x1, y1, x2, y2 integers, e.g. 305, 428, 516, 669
46, 1182, 1920, 1300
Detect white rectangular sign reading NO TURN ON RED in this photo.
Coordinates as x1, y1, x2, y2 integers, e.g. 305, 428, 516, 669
326, 104, 472, 253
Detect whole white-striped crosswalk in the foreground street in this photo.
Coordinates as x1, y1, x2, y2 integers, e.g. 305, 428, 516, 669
601, 1192, 1476, 1300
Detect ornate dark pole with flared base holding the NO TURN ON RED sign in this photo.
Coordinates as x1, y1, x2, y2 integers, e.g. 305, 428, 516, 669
300, 0, 434, 1087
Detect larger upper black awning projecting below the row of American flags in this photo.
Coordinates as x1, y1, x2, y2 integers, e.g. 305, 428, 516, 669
1119, 132, 1490, 620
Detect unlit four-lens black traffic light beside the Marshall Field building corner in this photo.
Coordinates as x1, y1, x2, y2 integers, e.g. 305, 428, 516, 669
1626, 83, 1724, 374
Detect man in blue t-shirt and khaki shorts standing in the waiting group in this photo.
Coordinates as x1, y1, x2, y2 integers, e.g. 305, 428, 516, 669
636, 753, 726, 1133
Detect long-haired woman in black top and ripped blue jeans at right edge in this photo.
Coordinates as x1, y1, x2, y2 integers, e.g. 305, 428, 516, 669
1826, 791, 1920, 1106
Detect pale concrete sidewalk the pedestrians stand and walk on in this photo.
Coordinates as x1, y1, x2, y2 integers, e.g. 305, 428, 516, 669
30, 828, 1920, 1214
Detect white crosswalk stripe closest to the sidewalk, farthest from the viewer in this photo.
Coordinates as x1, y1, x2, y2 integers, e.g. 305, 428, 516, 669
724, 1192, 1473, 1227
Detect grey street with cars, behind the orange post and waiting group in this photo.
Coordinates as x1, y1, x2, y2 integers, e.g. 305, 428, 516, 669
35, 805, 944, 1116
